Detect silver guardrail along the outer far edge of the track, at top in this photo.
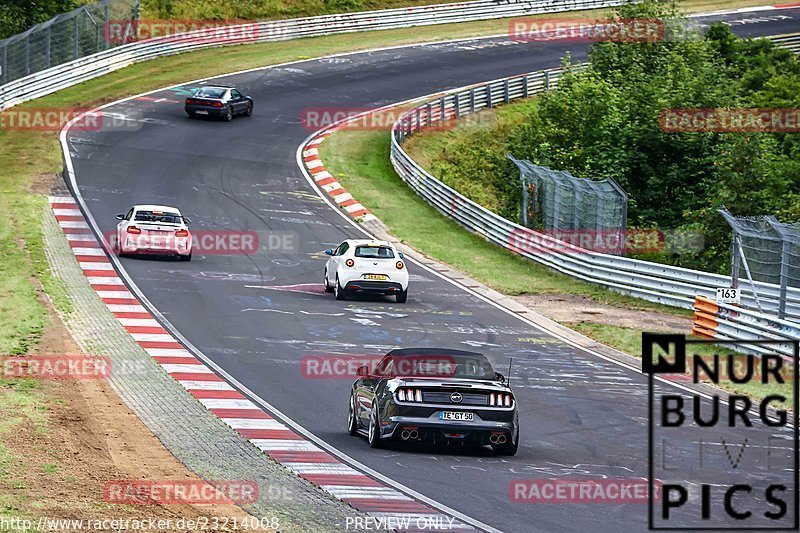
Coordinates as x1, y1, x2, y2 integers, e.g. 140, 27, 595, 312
0, 0, 625, 111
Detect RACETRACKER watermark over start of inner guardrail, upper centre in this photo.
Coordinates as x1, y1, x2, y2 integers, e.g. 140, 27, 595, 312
300, 103, 497, 131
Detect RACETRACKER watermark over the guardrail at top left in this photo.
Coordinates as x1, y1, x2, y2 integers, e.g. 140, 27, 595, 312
103, 19, 290, 45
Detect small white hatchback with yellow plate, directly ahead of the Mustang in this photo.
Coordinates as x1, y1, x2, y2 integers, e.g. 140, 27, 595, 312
324, 239, 408, 303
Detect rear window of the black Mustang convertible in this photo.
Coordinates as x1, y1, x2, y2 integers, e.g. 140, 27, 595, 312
376, 352, 495, 380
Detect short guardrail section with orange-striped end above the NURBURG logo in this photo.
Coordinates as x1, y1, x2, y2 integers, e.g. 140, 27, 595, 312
692, 296, 800, 359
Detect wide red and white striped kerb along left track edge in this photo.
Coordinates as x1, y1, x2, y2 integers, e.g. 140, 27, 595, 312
50, 195, 474, 531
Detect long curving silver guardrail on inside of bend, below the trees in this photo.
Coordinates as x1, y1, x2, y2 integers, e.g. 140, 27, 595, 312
390, 34, 800, 320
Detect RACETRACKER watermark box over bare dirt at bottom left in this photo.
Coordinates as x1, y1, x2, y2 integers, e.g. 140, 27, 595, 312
103, 480, 259, 505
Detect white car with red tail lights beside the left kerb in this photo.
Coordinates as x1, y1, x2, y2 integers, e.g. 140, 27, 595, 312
115, 205, 192, 261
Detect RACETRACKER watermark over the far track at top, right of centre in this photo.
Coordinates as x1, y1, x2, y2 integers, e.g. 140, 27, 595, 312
508, 18, 665, 43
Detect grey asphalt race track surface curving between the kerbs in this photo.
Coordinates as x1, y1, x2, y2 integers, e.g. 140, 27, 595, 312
69, 10, 800, 532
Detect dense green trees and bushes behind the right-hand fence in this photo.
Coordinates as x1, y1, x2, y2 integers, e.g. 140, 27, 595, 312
433, 0, 800, 273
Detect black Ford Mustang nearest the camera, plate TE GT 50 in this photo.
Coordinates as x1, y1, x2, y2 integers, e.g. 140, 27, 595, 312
348, 348, 519, 455
